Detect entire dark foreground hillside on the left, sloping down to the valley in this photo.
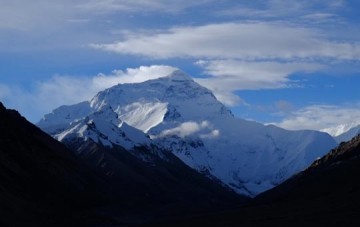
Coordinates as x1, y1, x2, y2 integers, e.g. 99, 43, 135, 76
0, 103, 246, 226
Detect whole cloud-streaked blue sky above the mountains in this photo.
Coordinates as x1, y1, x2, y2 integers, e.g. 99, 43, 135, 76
0, 0, 360, 129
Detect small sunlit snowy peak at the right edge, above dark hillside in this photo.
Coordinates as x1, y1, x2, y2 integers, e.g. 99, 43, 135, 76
321, 121, 360, 143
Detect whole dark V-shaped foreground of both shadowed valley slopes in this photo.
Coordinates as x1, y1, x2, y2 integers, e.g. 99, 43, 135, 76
4, 100, 360, 226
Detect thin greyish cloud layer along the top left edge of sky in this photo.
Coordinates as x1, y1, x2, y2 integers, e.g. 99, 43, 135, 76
0, 0, 213, 32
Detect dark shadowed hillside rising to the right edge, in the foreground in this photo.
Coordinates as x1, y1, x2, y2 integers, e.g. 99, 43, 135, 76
155, 136, 360, 226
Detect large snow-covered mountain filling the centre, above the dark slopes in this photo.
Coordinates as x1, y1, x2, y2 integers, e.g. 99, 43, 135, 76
38, 71, 336, 196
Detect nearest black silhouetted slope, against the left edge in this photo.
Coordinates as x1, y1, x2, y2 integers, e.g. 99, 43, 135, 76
0, 103, 112, 226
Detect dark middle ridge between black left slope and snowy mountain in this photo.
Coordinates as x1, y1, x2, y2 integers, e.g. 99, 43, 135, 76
63, 138, 249, 223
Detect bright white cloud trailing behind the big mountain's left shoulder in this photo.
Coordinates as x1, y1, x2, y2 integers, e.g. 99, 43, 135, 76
0, 65, 176, 121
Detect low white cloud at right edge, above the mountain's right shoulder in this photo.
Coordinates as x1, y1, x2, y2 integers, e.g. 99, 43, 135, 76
273, 105, 360, 130
